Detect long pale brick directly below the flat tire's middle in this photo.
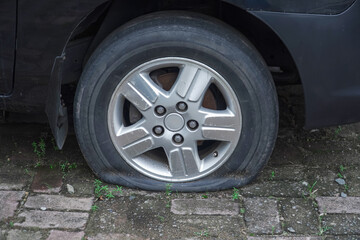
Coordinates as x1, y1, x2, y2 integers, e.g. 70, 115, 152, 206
171, 199, 239, 215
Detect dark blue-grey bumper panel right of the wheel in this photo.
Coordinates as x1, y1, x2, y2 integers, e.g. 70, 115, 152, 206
252, 1, 360, 128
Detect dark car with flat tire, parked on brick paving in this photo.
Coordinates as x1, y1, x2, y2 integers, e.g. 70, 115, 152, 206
0, 0, 360, 192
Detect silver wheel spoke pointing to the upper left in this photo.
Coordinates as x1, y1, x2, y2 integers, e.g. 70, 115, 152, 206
122, 74, 160, 111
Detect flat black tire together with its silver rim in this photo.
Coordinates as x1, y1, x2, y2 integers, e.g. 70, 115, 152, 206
74, 12, 278, 192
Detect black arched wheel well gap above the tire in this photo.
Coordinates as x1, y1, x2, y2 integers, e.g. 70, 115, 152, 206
63, 0, 300, 85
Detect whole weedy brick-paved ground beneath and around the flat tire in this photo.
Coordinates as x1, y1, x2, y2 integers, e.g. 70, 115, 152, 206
0, 123, 360, 240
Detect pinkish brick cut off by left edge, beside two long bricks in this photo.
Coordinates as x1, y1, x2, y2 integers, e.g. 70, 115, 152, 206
0, 191, 25, 221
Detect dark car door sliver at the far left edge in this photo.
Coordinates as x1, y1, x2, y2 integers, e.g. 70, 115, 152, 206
0, 0, 17, 96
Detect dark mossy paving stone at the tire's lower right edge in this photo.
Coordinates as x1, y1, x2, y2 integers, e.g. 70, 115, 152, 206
240, 181, 306, 197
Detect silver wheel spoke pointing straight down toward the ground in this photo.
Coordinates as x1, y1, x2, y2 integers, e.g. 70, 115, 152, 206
167, 144, 201, 177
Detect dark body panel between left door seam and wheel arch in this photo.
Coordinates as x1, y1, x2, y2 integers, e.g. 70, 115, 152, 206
0, 0, 106, 113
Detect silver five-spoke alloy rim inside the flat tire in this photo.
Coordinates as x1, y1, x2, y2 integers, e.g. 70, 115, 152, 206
108, 57, 242, 182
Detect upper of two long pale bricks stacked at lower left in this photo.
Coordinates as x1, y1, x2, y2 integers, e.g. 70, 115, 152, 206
25, 194, 93, 211
